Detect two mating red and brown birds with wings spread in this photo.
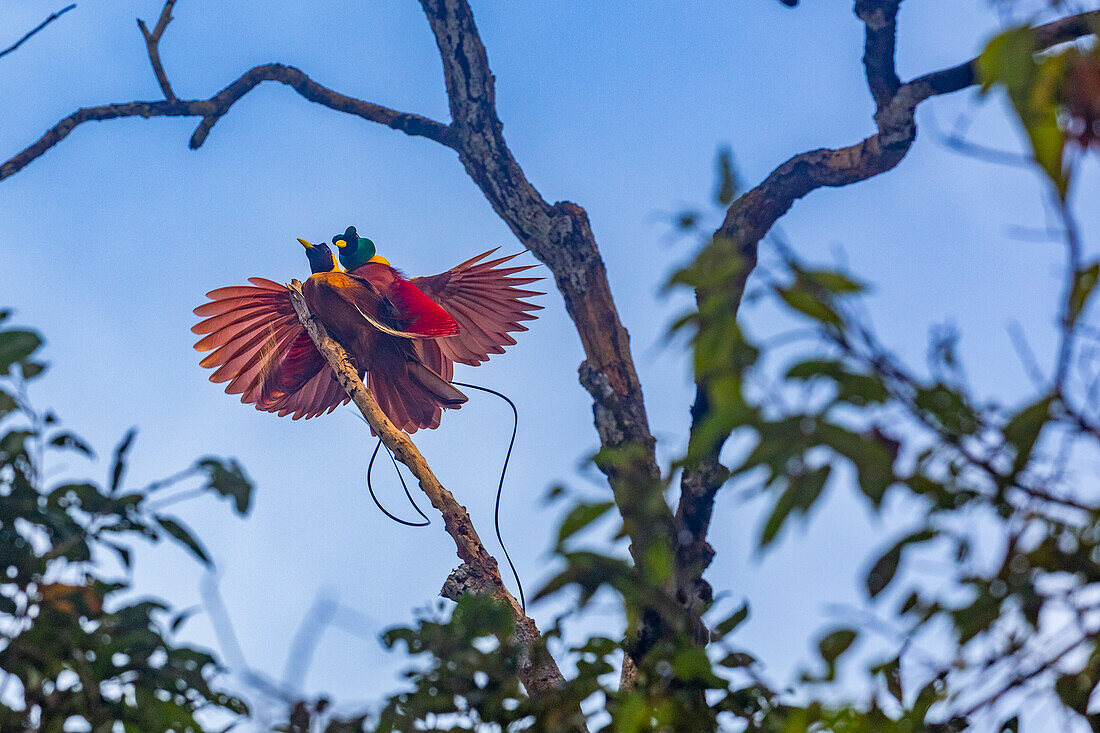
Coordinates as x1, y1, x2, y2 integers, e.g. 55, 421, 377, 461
191, 227, 542, 433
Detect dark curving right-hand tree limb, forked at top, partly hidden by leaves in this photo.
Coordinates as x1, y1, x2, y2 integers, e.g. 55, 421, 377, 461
677, 0, 1100, 620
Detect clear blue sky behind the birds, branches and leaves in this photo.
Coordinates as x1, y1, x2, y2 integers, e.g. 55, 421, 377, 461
0, 0, 1100, 721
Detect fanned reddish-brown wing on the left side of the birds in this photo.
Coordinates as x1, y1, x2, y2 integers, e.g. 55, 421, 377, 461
191, 277, 349, 419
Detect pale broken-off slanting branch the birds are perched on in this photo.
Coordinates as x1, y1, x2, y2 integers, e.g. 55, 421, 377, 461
287, 281, 585, 717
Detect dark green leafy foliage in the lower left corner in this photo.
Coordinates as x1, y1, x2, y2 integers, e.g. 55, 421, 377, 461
0, 311, 252, 733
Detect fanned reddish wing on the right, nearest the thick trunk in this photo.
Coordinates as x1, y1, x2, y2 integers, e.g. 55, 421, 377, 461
409, 249, 543, 367
